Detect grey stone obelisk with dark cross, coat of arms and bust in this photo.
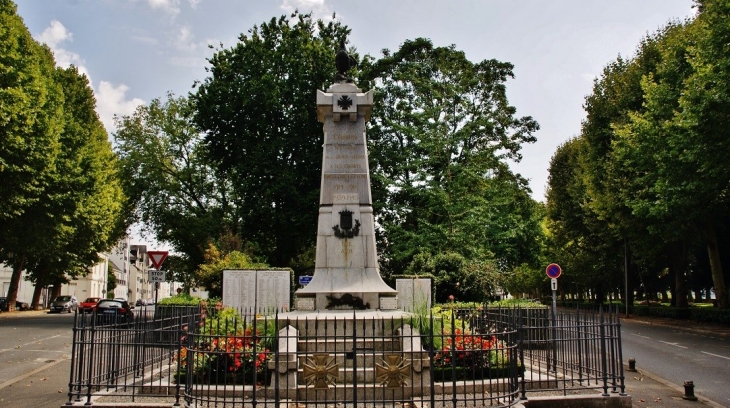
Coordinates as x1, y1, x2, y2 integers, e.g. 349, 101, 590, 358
296, 56, 398, 310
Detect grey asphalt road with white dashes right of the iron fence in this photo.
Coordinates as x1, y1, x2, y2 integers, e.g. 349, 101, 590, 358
621, 320, 730, 406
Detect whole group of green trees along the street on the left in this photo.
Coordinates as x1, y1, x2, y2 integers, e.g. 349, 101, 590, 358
0, 0, 126, 308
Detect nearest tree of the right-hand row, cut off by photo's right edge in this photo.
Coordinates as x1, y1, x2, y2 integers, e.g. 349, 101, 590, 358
672, 0, 730, 308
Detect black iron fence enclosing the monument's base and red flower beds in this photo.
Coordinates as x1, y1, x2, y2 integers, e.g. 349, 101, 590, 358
69, 307, 624, 407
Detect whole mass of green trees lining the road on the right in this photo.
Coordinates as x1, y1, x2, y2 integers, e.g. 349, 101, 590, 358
547, 0, 730, 307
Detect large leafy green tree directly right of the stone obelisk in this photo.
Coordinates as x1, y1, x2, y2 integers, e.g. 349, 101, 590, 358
363, 38, 540, 286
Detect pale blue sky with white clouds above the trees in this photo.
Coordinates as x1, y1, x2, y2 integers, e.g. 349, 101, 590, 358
16, 0, 695, 201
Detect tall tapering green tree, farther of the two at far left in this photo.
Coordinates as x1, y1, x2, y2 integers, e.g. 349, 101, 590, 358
26, 66, 127, 306
